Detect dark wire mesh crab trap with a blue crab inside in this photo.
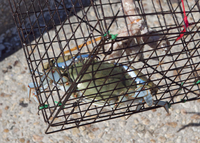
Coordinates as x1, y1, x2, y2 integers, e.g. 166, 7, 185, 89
9, 0, 200, 133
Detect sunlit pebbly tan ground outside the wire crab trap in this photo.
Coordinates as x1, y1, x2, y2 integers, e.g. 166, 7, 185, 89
0, 0, 200, 143
